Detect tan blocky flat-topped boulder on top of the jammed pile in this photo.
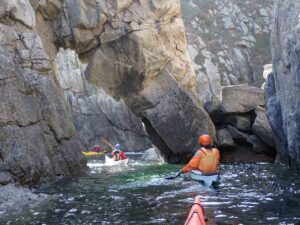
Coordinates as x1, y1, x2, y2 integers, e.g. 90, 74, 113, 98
221, 84, 265, 113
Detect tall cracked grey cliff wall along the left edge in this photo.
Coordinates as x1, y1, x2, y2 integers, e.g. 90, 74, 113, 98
0, 26, 85, 185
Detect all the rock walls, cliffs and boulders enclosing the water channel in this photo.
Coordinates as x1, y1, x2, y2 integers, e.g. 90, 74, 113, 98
0, 0, 300, 219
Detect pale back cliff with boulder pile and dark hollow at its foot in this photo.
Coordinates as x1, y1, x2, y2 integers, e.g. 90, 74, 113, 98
181, 0, 276, 162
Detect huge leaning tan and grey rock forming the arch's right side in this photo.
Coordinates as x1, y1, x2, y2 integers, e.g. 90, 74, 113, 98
86, 0, 215, 162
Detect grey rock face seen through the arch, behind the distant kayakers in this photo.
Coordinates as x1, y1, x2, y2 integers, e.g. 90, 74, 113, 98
56, 49, 151, 151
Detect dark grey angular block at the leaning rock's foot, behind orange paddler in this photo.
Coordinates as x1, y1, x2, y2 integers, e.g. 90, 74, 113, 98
142, 82, 215, 160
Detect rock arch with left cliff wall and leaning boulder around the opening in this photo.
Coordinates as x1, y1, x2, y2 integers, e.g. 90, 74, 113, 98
0, 0, 215, 184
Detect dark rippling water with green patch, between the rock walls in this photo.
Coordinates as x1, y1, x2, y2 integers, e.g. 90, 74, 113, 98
1, 155, 300, 225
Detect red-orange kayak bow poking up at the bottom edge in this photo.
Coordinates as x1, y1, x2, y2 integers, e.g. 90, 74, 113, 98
184, 196, 206, 225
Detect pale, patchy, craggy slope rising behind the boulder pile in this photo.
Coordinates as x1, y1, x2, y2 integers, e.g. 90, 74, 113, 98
181, 0, 273, 114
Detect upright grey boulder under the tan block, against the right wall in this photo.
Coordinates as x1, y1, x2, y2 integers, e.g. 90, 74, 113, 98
252, 107, 275, 147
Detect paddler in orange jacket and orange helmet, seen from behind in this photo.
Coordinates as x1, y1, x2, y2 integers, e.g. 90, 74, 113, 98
179, 134, 220, 175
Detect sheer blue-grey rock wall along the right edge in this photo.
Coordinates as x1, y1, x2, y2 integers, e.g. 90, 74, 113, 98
265, 0, 300, 162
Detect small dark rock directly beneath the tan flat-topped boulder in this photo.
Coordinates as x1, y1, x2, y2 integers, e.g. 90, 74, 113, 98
225, 115, 252, 131
